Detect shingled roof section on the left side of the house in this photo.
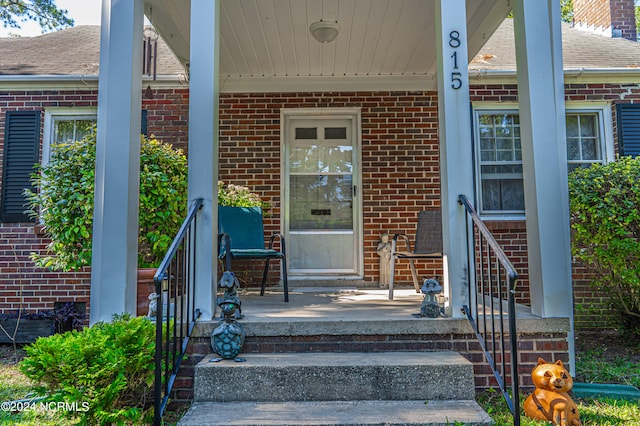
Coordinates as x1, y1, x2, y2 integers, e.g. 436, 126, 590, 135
0, 25, 184, 76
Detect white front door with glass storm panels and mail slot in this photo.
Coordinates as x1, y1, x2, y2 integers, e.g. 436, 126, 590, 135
282, 111, 362, 278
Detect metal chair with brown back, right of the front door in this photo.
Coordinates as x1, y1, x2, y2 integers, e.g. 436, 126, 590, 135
389, 208, 442, 300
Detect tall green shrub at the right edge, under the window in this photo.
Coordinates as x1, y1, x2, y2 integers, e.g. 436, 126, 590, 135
569, 157, 640, 333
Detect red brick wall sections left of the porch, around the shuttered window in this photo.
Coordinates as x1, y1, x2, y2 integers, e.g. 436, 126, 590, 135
0, 89, 188, 313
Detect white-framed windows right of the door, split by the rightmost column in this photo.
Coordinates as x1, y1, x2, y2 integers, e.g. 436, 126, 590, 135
474, 106, 613, 217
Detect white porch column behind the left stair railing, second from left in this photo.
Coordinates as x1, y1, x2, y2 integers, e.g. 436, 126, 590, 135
189, 0, 220, 320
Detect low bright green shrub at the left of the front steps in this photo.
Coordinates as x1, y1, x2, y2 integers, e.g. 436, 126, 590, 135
20, 315, 155, 425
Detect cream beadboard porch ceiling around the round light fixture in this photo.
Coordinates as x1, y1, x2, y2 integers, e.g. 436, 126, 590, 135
145, 0, 510, 90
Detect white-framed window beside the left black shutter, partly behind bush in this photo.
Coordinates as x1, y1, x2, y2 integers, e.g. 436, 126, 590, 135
42, 108, 97, 164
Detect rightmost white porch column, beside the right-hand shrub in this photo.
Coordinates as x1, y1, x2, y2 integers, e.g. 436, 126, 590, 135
513, 0, 575, 369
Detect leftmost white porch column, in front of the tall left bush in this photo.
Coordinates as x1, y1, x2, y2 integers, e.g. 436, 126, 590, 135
90, 0, 143, 324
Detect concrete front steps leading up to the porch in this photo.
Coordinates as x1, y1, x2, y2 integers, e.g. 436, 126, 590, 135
179, 352, 491, 426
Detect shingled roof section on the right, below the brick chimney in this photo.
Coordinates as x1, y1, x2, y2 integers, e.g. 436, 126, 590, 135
469, 19, 640, 70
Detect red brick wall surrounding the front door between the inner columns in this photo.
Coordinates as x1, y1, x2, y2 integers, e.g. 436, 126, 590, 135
219, 92, 442, 283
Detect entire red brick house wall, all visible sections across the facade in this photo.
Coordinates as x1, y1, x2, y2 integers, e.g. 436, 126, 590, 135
5, 83, 640, 324
